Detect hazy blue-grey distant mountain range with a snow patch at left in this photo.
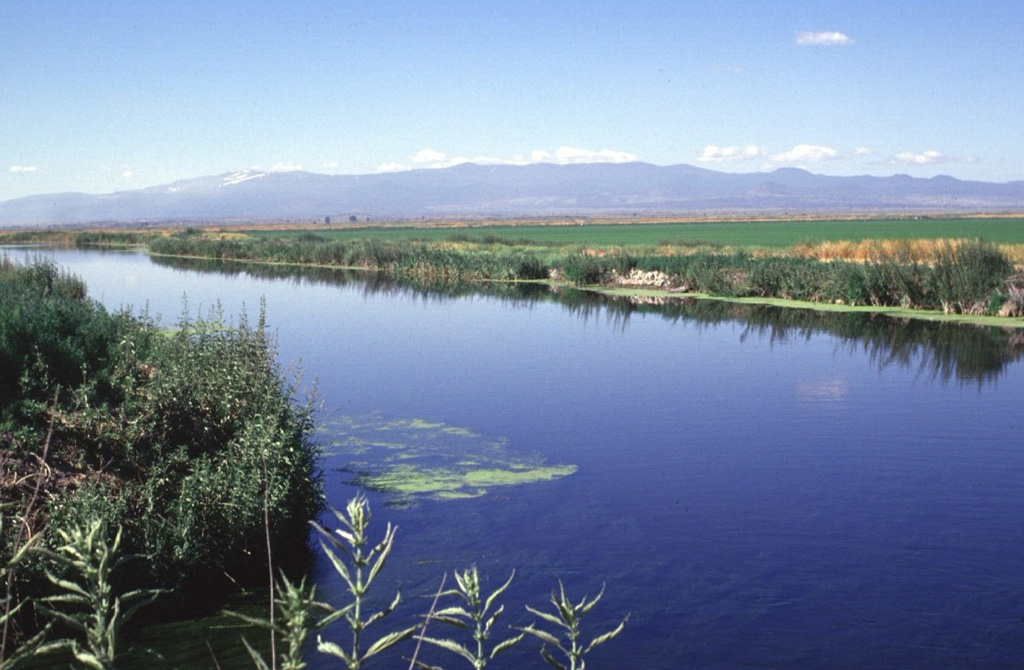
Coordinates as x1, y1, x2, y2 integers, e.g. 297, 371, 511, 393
0, 163, 1024, 227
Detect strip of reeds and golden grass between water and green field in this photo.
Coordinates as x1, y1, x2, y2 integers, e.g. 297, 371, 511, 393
136, 233, 1024, 323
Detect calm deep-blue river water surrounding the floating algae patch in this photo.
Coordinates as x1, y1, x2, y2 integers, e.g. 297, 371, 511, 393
9, 251, 1024, 670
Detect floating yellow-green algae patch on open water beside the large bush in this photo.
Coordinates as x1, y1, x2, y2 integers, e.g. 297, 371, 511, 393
324, 413, 577, 505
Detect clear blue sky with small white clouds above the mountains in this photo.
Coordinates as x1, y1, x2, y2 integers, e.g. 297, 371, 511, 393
0, 0, 1024, 200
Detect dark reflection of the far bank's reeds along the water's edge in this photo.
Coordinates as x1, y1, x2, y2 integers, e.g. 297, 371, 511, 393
153, 257, 1024, 385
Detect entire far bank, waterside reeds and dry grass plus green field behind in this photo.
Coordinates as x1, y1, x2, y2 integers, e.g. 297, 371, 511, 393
4, 217, 1024, 318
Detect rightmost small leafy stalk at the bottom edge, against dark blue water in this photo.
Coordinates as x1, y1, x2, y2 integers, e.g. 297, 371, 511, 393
519, 580, 630, 670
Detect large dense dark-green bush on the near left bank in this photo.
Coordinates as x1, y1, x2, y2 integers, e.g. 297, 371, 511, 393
0, 260, 321, 606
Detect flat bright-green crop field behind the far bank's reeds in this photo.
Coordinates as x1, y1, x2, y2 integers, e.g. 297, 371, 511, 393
240, 218, 1024, 247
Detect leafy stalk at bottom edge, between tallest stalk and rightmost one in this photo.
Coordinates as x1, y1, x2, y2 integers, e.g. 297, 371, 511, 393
417, 566, 525, 670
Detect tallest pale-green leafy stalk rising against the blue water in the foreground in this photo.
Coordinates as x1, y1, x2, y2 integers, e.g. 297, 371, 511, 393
313, 494, 417, 670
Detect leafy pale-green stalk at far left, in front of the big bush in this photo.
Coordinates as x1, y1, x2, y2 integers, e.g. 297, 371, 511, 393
37, 519, 162, 670
